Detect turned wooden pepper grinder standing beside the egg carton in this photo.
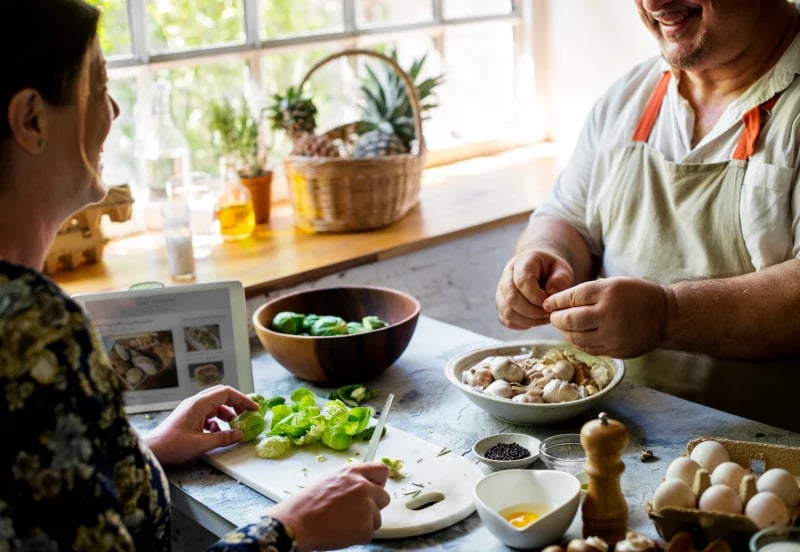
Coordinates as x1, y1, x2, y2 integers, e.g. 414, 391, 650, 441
581, 412, 628, 550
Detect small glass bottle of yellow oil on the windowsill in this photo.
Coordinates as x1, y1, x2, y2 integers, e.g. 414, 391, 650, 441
215, 159, 256, 241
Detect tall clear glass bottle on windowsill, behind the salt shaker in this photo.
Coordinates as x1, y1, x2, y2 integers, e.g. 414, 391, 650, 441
142, 80, 191, 230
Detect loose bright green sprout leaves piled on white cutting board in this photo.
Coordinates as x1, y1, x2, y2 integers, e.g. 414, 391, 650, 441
254, 387, 374, 462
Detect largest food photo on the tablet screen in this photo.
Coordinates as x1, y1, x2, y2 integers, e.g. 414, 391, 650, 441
104, 330, 178, 391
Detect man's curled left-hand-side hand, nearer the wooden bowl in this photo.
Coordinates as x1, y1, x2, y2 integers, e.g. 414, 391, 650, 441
495, 250, 575, 330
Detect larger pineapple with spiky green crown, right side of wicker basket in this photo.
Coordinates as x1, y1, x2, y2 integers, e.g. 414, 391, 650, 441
352, 51, 443, 157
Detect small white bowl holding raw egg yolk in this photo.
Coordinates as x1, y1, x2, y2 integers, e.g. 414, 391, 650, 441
473, 470, 581, 548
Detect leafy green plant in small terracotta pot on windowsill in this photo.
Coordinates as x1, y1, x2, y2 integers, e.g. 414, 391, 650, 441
209, 97, 272, 224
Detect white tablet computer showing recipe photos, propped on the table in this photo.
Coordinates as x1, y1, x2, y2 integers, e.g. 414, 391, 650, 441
74, 281, 253, 413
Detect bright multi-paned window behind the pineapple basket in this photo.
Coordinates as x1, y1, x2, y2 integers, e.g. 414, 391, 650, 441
88, 0, 535, 211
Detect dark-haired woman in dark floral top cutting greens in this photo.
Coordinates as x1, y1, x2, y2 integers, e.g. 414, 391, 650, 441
0, 0, 389, 551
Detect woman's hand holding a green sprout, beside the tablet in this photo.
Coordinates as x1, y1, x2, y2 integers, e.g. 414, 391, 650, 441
144, 385, 258, 464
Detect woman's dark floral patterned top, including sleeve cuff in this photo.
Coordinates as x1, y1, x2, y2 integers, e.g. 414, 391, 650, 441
0, 260, 295, 552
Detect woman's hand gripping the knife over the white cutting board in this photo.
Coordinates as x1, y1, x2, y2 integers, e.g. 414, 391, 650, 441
268, 462, 389, 550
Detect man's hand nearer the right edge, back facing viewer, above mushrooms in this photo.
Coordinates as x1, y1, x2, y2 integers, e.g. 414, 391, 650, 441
542, 278, 668, 358
